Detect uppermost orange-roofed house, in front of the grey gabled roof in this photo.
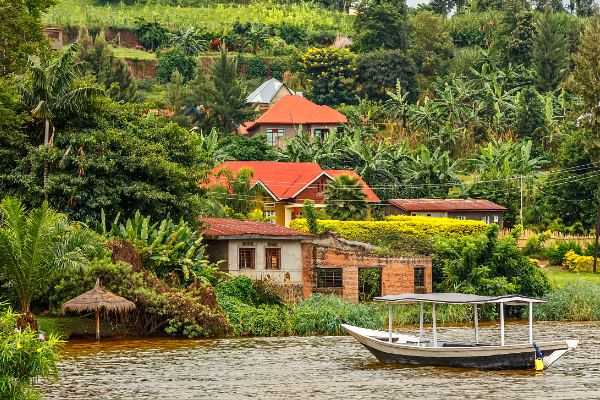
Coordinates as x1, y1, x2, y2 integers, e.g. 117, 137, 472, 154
239, 95, 348, 147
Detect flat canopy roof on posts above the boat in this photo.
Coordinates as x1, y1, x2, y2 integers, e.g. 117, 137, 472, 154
373, 293, 548, 306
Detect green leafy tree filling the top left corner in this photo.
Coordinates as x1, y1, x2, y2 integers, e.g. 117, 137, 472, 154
0, 0, 58, 73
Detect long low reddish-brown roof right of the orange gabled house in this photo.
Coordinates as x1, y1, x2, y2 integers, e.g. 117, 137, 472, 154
388, 199, 508, 211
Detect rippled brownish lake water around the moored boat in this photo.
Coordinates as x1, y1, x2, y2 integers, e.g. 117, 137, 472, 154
42, 322, 600, 400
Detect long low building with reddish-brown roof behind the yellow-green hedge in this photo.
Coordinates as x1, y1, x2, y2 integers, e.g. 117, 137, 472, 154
385, 199, 508, 230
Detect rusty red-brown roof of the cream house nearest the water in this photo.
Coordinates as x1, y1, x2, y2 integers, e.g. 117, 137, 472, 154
200, 218, 313, 236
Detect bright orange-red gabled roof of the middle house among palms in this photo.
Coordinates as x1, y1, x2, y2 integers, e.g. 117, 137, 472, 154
209, 161, 379, 202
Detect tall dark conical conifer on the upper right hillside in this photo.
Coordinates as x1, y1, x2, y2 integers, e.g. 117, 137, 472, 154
532, 7, 569, 92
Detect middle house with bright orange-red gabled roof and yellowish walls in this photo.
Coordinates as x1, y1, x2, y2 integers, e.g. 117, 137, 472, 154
209, 161, 379, 226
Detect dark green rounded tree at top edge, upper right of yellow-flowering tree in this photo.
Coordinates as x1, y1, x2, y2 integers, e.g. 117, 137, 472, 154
353, 0, 410, 53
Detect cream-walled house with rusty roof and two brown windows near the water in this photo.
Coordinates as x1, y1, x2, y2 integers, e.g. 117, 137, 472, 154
200, 218, 314, 300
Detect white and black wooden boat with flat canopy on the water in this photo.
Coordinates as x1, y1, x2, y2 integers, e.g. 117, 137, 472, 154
342, 293, 578, 370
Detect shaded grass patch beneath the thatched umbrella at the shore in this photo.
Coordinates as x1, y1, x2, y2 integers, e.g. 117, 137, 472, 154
35, 315, 126, 340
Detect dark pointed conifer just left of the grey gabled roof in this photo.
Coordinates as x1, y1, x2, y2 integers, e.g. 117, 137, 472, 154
192, 46, 256, 134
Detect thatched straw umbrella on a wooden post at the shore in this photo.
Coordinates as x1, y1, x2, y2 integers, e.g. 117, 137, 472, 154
61, 279, 135, 340
